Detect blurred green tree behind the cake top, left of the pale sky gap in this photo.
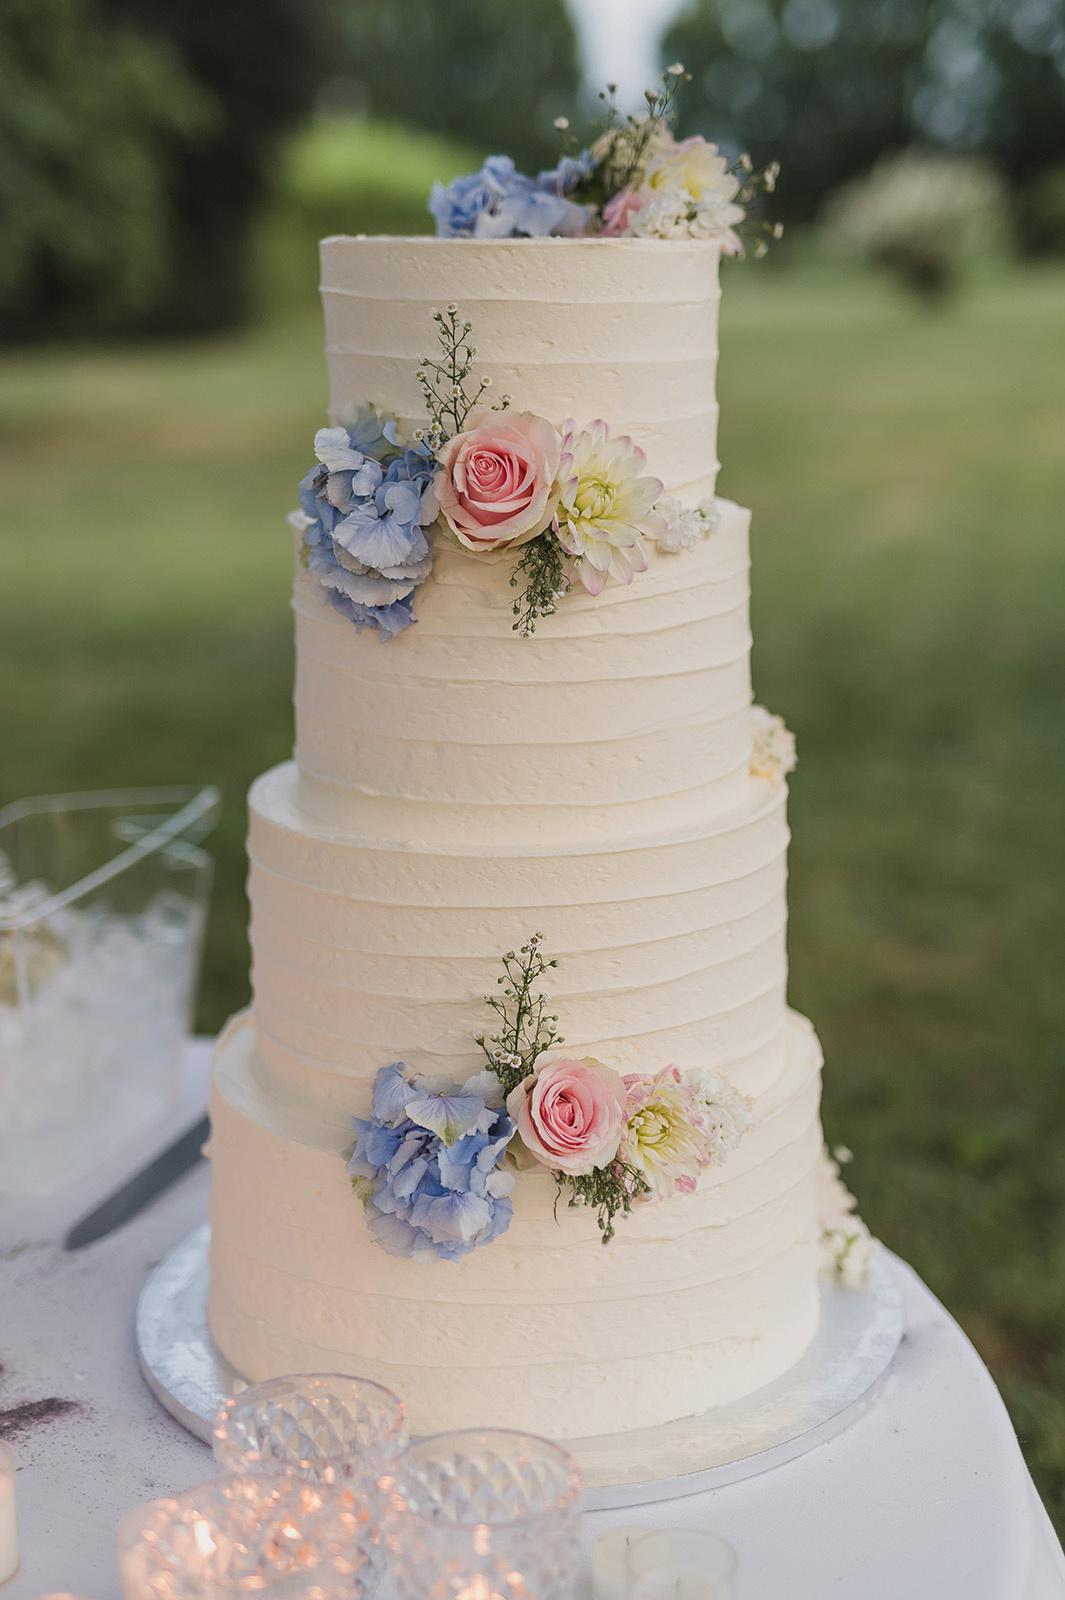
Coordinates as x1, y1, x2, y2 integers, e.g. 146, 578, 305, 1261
334, 0, 580, 170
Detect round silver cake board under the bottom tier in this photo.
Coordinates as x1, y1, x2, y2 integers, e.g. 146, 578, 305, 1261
136, 1224, 902, 1510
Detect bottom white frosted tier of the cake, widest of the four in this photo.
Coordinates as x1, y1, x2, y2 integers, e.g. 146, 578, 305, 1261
209, 1013, 822, 1438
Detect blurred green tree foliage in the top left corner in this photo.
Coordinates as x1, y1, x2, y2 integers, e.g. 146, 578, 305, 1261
0, 0, 209, 339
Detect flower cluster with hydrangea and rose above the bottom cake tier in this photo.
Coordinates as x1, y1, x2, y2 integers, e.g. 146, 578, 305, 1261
347, 933, 750, 1261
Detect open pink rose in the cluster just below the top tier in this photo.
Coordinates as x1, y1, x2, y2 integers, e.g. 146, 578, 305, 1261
433, 410, 561, 550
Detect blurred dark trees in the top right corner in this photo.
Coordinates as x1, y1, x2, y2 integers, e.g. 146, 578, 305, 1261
662, 0, 1065, 241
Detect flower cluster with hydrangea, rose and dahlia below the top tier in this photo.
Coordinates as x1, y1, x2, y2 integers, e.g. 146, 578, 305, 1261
289, 306, 718, 640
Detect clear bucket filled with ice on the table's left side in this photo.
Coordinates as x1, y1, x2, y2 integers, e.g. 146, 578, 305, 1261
0, 787, 219, 1197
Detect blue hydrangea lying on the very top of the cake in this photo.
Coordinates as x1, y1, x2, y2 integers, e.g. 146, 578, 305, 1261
429, 155, 592, 238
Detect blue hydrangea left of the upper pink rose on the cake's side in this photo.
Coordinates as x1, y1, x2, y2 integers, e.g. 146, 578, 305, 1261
296, 406, 437, 640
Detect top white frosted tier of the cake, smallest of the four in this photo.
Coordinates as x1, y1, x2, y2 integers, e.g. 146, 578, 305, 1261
321, 238, 720, 502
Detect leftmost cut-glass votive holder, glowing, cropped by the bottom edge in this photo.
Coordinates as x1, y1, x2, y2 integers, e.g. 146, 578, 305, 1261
118, 1474, 364, 1600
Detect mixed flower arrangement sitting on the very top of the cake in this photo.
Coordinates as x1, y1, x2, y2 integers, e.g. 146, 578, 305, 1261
429, 61, 782, 256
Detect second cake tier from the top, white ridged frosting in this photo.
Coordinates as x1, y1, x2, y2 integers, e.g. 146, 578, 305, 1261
294, 502, 752, 843
